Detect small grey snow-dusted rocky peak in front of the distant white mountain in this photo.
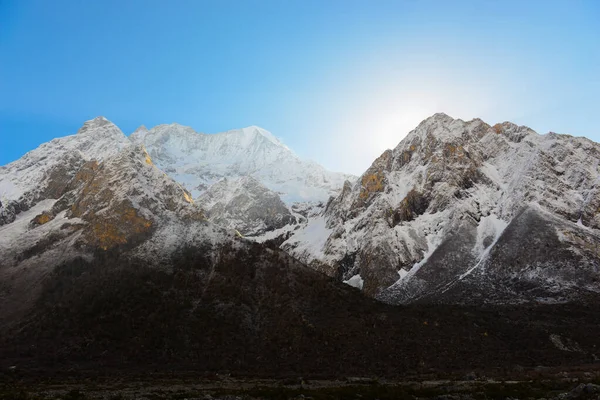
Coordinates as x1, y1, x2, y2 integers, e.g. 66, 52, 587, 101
198, 177, 296, 236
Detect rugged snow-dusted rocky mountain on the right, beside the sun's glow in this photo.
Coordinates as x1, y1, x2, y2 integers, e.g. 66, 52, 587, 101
282, 114, 600, 304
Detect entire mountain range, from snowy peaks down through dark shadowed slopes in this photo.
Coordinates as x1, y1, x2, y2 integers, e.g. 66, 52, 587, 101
0, 114, 600, 375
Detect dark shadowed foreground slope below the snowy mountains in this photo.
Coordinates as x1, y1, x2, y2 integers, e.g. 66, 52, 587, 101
0, 242, 600, 377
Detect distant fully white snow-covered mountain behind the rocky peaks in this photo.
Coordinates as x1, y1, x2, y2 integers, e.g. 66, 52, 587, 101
130, 124, 353, 205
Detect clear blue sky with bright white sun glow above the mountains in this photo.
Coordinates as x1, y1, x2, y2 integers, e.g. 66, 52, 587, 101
0, 0, 600, 174
